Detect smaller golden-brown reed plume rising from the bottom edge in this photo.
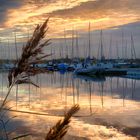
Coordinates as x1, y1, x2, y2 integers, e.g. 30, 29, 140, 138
45, 105, 80, 140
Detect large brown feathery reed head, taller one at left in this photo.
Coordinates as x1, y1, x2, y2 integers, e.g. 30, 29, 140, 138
8, 19, 51, 86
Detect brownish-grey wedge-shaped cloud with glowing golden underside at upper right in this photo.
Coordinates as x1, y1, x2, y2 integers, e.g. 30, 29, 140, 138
51, 0, 140, 29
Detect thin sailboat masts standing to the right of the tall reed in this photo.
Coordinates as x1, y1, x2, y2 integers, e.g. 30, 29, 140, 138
54, 22, 137, 60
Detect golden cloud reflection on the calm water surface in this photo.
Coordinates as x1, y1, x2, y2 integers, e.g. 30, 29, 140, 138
6, 74, 140, 140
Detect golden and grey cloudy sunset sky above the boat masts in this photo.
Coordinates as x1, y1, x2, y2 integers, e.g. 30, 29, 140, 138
0, 0, 140, 57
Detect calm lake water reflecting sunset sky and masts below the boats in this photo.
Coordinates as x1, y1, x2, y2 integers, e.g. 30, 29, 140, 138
0, 72, 140, 140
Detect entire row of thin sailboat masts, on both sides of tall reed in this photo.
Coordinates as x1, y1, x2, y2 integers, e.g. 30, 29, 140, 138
0, 22, 137, 60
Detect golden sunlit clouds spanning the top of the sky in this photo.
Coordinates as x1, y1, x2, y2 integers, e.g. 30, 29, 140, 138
0, 0, 140, 37
